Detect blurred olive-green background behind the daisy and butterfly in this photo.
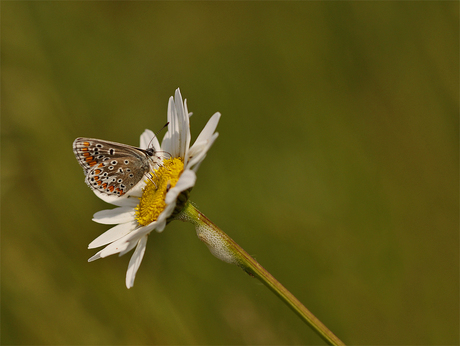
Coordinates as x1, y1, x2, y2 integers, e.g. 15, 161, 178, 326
1, 1, 459, 345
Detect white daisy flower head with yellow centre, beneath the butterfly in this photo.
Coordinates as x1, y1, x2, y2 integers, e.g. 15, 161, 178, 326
88, 89, 220, 288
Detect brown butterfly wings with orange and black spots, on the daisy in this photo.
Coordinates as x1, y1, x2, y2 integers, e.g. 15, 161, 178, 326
73, 138, 155, 196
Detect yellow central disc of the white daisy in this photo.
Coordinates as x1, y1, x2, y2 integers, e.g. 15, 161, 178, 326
136, 157, 184, 226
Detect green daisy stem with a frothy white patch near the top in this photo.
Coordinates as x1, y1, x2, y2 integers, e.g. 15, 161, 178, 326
176, 202, 345, 345
